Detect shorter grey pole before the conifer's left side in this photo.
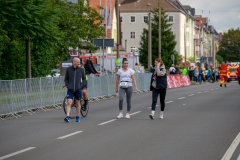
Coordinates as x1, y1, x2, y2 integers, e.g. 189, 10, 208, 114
148, 13, 152, 68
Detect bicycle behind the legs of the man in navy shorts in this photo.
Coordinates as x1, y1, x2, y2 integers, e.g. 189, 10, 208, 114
63, 93, 89, 119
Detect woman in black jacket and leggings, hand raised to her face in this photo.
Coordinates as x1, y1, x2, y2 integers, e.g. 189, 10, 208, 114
149, 58, 167, 119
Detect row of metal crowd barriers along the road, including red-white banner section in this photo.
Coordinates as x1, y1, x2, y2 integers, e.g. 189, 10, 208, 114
0, 73, 191, 119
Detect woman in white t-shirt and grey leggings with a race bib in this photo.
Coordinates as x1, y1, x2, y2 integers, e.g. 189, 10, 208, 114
116, 58, 138, 118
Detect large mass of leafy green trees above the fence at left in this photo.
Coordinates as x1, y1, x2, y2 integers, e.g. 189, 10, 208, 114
0, 0, 104, 79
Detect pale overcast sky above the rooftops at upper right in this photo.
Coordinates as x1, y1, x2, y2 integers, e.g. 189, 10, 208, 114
179, 0, 240, 32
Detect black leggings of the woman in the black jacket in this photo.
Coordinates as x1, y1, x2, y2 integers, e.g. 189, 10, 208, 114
152, 88, 167, 111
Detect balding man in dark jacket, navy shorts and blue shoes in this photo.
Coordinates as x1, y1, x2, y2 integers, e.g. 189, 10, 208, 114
64, 57, 86, 122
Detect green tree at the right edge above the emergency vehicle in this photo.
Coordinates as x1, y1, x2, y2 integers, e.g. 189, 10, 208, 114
217, 28, 240, 62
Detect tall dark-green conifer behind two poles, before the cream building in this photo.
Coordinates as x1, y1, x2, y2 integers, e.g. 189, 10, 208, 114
139, 8, 179, 68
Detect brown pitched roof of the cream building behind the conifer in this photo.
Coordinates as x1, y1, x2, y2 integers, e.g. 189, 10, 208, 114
119, 0, 185, 13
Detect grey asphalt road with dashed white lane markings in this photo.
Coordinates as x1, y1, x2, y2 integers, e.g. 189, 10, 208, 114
0, 82, 240, 160
